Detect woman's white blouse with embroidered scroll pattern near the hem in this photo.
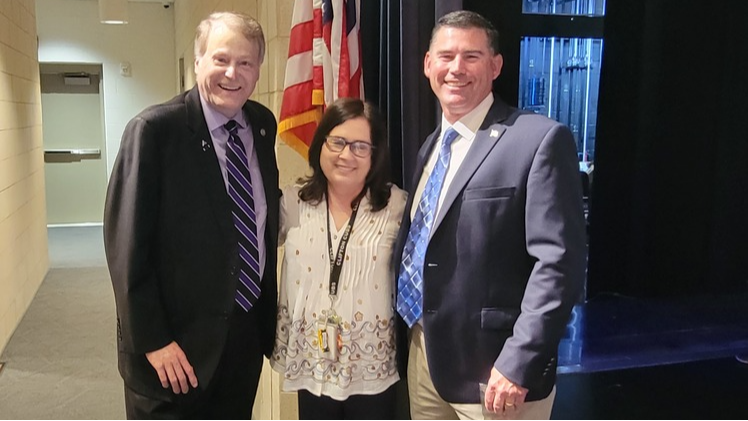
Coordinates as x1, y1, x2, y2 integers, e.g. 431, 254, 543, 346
270, 185, 407, 400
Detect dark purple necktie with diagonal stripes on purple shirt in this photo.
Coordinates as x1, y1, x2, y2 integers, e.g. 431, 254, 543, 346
223, 120, 260, 311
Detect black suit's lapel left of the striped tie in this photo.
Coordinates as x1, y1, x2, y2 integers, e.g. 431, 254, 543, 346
185, 87, 234, 238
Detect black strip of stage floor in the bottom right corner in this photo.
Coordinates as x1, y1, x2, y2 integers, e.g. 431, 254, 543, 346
551, 358, 748, 420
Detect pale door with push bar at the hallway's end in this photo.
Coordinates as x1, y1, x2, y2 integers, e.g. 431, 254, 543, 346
39, 63, 107, 225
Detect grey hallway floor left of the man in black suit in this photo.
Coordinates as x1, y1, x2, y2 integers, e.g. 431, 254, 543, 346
0, 226, 125, 420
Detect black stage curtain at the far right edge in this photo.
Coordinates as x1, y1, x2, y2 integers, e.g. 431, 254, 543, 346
587, 0, 748, 298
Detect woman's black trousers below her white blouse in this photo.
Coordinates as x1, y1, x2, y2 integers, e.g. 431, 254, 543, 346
298, 385, 396, 420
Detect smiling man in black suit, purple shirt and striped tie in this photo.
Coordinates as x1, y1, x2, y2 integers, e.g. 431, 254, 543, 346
104, 13, 280, 419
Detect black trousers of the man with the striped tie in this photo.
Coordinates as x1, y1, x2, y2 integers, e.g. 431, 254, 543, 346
125, 306, 262, 420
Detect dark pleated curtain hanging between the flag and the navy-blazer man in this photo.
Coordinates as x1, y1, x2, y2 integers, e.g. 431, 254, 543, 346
361, 0, 462, 187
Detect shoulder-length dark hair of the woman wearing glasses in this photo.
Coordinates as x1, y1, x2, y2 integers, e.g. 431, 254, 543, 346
299, 98, 390, 212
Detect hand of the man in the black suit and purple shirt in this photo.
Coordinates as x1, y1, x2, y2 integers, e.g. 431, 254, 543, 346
145, 341, 197, 393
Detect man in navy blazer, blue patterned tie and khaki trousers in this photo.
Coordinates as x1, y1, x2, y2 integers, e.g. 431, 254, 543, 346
394, 11, 586, 419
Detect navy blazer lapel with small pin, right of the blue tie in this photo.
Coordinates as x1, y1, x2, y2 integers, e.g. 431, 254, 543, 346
432, 98, 508, 232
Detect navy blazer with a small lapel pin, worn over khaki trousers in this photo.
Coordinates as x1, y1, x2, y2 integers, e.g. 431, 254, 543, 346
393, 98, 586, 403
